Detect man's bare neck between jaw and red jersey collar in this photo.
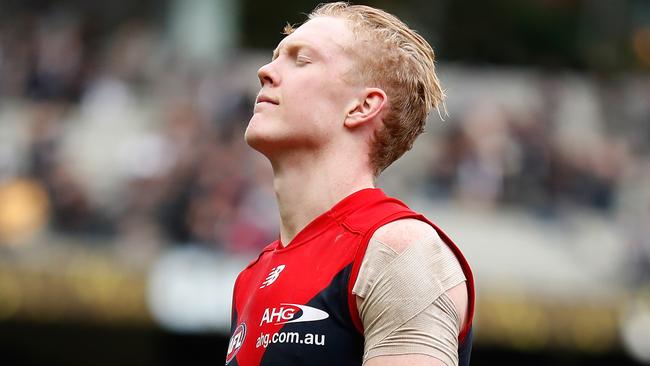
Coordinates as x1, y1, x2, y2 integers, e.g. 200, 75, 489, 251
272, 149, 374, 246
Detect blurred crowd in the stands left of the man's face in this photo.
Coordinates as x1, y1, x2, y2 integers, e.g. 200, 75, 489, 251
0, 13, 277, 255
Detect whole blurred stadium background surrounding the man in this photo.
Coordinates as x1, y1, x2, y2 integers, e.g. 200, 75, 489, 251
0, 0, 650, 365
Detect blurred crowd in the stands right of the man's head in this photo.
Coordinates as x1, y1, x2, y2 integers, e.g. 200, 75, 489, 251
424, 73, 650, 284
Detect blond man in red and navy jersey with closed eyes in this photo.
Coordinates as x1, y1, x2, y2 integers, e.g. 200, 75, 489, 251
226, 3, 474, 366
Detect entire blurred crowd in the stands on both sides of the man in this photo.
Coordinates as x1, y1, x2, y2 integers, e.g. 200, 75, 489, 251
0, 7, 650, 278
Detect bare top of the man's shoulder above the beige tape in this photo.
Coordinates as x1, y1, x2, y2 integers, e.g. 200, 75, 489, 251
372, 219, 438, 253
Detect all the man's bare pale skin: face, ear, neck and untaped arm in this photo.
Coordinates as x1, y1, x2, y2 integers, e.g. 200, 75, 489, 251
246, 17, 467, 366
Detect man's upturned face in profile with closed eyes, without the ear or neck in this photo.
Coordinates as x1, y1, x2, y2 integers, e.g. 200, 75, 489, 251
246, 17, 358, 157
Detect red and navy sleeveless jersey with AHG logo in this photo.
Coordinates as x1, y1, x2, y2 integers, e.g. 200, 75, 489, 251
226, 188, 474, 366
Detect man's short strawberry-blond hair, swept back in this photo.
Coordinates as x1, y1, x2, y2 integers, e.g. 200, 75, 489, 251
284, 2, 445, 176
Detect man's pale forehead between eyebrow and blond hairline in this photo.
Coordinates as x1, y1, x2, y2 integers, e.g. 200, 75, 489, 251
276, 16, 354, 56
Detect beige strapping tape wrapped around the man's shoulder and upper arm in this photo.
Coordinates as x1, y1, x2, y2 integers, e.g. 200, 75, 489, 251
352, 234, 465, 366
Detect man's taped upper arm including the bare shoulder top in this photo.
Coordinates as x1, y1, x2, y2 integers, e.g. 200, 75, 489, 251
355, 219, 468, 366
